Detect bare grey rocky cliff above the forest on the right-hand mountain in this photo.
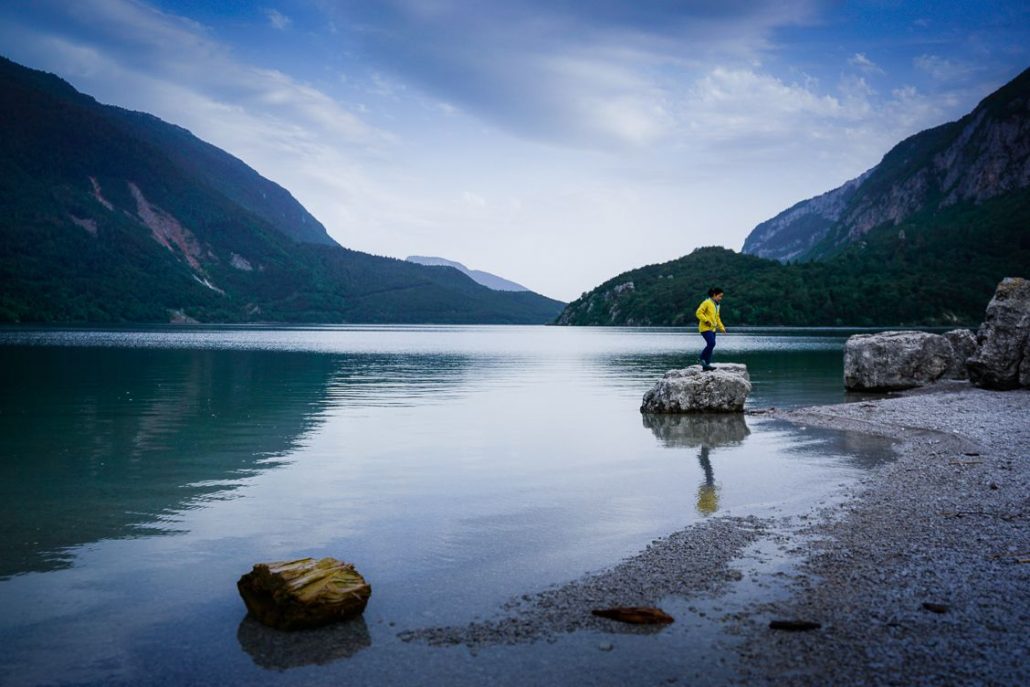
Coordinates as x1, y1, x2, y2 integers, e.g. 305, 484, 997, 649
743, 69, 1030, 261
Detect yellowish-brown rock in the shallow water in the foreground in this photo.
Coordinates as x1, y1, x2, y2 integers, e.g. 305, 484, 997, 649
236, 558, 372, 629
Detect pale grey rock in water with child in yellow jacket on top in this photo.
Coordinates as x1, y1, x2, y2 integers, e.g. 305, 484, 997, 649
641, 364, 751, 413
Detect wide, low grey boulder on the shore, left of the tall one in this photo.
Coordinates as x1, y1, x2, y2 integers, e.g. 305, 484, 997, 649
844, 332, 955, 391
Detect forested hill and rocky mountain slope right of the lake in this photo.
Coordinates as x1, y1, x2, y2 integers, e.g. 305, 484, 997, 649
558, 71, 1030, 327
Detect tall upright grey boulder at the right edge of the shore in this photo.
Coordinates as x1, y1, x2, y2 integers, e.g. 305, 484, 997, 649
966, 277, 1030, 389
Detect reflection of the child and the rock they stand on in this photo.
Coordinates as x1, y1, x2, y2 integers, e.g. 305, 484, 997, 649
643, 413, 751, 515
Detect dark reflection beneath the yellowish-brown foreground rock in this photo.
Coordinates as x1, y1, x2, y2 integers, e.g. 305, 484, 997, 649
236, 614, 372, 672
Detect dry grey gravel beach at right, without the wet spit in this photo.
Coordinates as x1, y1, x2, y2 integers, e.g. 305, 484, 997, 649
735, 383, 1030, 686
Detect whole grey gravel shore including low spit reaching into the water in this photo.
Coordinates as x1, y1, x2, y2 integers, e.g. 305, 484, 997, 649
402, 382, 1030, 686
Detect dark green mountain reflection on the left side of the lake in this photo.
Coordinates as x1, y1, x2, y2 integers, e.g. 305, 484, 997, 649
0, 347, 466, 579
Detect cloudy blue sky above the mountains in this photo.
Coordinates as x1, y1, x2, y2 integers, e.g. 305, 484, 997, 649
0, 0, 1030, 301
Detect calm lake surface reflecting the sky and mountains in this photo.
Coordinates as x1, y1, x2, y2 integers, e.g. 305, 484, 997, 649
0, 327, 891, 685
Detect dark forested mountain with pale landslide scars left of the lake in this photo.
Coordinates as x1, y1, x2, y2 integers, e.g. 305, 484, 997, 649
0, 58, 562, 323
